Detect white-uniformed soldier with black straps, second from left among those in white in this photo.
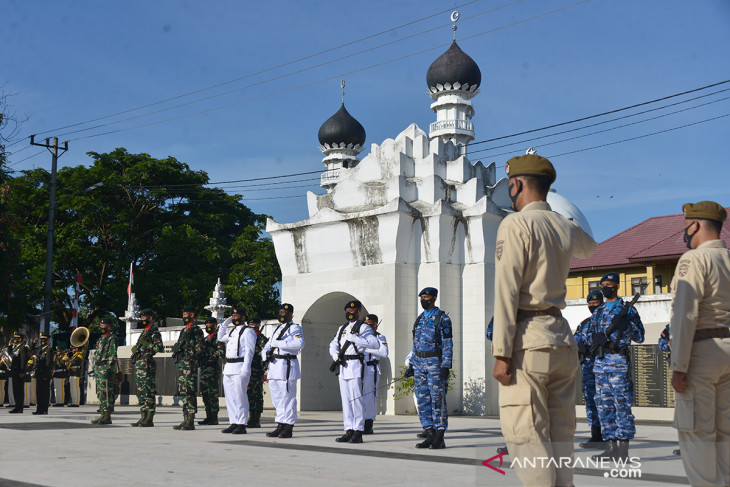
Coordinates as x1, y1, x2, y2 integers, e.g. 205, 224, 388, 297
261, 303, 304, 438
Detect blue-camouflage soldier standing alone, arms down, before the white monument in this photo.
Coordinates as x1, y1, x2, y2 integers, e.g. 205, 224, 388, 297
411, 287, 453, 449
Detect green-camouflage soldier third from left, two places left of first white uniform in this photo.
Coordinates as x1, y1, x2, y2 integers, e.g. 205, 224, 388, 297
172, 306, 203, 430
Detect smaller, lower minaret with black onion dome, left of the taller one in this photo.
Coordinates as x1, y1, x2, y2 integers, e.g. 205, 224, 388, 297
318, 80, 365, 193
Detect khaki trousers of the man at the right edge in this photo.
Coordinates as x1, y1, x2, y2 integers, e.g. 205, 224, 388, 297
674, 338, 730, 486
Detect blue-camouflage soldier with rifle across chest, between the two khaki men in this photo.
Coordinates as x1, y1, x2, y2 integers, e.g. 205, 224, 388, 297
582, 272, 644, 459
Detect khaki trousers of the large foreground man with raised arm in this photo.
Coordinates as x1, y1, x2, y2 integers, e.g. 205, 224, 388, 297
499, 346, 578, 486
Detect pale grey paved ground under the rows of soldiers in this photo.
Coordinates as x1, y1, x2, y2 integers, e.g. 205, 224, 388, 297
0, 406, 687, 487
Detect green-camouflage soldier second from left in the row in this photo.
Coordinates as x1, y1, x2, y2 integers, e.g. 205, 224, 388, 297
132, 309, 165, 427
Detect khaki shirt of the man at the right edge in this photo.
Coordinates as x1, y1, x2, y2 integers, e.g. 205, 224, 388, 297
669, 240, 730, 372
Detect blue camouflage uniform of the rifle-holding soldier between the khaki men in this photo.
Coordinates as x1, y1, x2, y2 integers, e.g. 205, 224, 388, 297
581, 299, 644, 441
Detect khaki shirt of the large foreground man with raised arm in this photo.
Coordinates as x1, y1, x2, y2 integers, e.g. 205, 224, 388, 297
492, 201, 596, 357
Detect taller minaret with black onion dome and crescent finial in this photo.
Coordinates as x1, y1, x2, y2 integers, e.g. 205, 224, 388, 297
426, 11, 482, 154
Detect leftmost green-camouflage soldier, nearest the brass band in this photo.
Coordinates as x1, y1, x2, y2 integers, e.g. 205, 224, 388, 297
91, 318, 118, 424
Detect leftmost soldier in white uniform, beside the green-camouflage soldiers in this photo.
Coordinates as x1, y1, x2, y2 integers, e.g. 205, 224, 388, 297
218, 307, 256, 435
